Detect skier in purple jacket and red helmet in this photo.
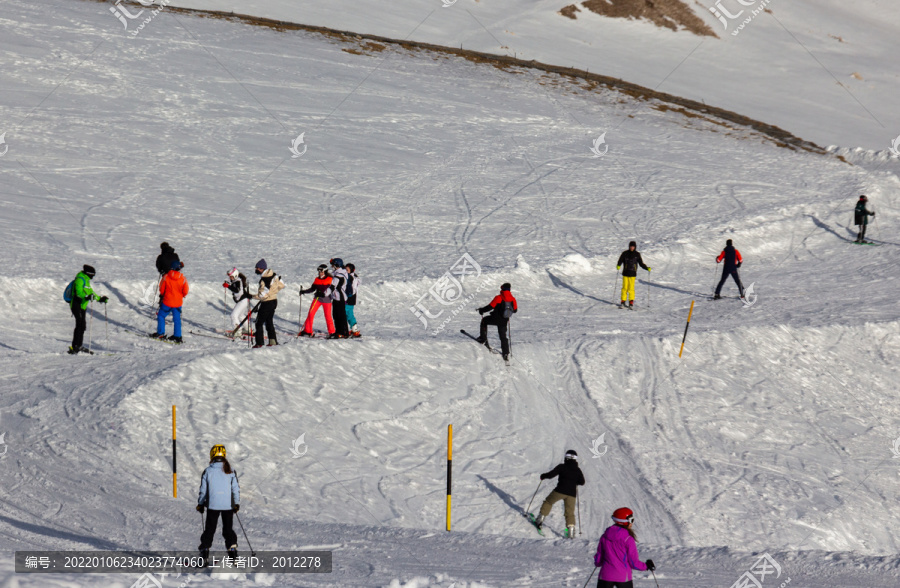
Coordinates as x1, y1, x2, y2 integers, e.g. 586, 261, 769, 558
594, 508, 656, 588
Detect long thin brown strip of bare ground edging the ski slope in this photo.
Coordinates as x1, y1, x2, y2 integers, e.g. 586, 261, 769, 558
100, 0, 828, 156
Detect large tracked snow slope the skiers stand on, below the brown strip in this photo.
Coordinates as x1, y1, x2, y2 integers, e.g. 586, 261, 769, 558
0, 0, 900, 588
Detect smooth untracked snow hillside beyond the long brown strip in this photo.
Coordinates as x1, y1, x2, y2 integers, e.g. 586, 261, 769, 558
162, 0, 900, 151
